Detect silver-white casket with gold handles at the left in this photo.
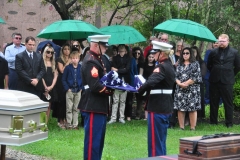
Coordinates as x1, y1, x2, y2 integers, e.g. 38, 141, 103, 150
0, 89, 48, 146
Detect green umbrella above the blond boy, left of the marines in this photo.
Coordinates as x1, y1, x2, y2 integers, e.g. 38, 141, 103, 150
37, 20, 103, 40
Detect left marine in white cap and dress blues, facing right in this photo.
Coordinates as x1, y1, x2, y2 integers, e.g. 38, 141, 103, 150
79, 35, 112, 160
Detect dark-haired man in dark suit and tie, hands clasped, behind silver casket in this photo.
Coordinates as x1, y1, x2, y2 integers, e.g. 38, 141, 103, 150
15, 36, 46, 96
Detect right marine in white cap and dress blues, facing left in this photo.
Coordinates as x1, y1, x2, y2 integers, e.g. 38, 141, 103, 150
139, 41, 175, 157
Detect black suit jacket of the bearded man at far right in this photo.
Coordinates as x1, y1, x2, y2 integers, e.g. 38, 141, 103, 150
207, 46, 240, 85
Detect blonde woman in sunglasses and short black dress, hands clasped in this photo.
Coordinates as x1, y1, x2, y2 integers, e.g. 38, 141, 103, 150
41, 46, 58, 123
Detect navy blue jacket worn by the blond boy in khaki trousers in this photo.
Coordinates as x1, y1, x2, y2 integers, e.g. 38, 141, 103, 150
62, 64, 82, 92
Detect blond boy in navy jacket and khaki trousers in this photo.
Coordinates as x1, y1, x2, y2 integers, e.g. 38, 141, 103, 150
62, 51, 82, 129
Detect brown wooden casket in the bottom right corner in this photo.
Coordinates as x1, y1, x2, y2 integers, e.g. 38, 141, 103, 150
178, 134, 240, 160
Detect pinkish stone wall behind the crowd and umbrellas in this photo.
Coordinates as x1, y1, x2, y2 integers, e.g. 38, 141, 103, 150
0, 0, 133, 50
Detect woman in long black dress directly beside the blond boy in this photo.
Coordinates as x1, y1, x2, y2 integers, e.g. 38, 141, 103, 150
56, 44, 71, 129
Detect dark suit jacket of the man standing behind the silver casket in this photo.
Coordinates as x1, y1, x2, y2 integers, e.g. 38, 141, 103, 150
15, 51, 46, 95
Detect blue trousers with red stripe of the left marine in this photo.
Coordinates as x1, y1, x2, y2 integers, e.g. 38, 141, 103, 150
82, 112, 107, 160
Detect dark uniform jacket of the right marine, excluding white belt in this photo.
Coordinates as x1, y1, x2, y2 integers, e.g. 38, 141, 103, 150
139, 59, 175, 114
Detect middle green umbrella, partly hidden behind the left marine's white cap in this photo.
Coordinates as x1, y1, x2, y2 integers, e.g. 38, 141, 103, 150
100, 25, 146, 45
